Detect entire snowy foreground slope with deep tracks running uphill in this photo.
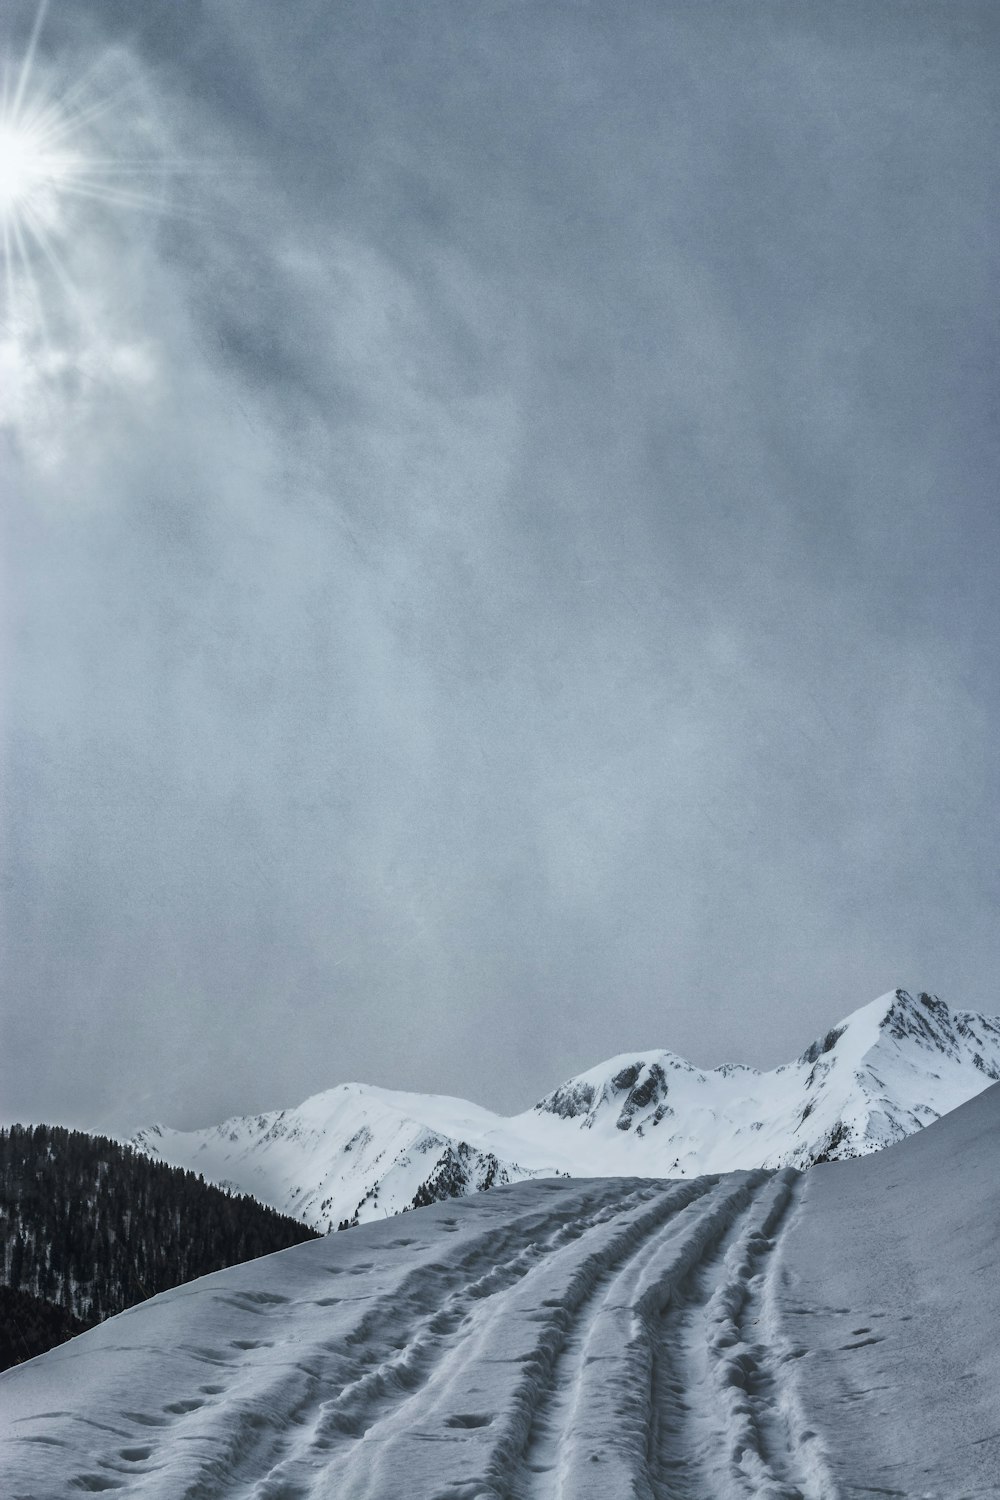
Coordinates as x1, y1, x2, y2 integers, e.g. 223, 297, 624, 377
7, 1089, 1000, 1500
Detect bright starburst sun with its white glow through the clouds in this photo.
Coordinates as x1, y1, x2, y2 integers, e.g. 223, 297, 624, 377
0, 0, 197, 441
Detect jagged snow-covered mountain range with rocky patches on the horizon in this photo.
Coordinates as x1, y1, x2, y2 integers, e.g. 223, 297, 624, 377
132, 990, 1000, 1230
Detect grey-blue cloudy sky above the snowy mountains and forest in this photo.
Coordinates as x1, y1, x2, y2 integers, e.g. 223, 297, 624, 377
0, 0, 1000, 1130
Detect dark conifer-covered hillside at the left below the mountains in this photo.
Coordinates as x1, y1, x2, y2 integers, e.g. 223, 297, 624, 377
0, 1125, 316, 1370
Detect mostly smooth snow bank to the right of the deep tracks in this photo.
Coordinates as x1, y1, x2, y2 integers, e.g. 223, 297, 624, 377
774, 1088, 1000, 1500
